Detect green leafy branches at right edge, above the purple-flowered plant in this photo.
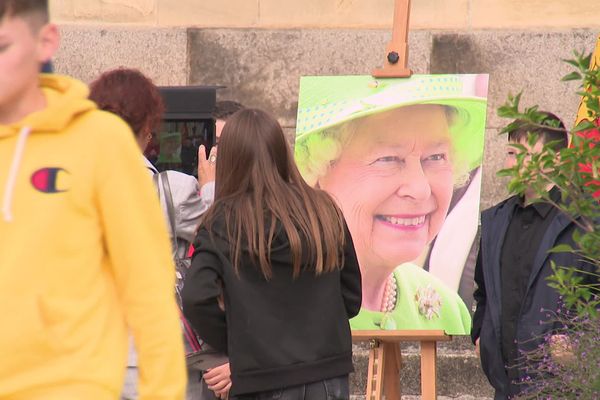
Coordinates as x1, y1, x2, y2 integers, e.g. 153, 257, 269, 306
498, 52, 600, 312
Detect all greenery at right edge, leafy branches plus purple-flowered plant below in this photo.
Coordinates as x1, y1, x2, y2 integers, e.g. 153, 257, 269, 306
498, 52, 600, 399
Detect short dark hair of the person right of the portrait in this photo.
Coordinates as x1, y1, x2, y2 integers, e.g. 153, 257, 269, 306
508, 111, 569, 151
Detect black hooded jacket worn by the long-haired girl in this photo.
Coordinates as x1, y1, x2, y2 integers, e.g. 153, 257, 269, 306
182, 214, 361, 395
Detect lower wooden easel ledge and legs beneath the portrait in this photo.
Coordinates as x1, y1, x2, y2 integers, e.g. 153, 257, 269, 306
352, 330, 452, 400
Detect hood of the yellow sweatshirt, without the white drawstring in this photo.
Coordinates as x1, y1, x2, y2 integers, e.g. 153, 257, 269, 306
0, 74, 96, 138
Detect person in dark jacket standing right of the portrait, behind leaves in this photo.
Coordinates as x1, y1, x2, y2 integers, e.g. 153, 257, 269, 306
471, 113, 592, 400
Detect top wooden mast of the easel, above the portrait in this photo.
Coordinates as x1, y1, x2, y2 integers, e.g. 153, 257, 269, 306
371, 0, 412, 78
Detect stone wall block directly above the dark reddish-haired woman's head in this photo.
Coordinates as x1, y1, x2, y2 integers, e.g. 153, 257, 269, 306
53, 25, 188, 85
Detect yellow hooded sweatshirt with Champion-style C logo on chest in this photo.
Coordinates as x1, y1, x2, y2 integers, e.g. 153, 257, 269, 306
0, 75, 186, 400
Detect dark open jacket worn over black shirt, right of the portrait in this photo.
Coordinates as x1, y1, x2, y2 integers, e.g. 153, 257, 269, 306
471, 196, 594, 400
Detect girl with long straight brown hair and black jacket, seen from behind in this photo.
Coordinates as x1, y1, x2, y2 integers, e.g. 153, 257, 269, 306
182, 109, 361, 400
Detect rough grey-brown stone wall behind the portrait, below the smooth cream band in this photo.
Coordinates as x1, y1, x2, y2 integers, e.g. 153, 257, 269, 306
55, 25, 597, 207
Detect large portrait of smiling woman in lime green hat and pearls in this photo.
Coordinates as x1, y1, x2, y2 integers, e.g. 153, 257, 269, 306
295, 74, 488, 335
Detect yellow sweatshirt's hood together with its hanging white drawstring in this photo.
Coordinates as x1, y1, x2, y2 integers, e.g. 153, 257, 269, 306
0, 74, 96, 222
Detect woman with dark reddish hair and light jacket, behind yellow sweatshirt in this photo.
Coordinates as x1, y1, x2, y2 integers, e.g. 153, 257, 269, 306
90, 68, 215, 400
